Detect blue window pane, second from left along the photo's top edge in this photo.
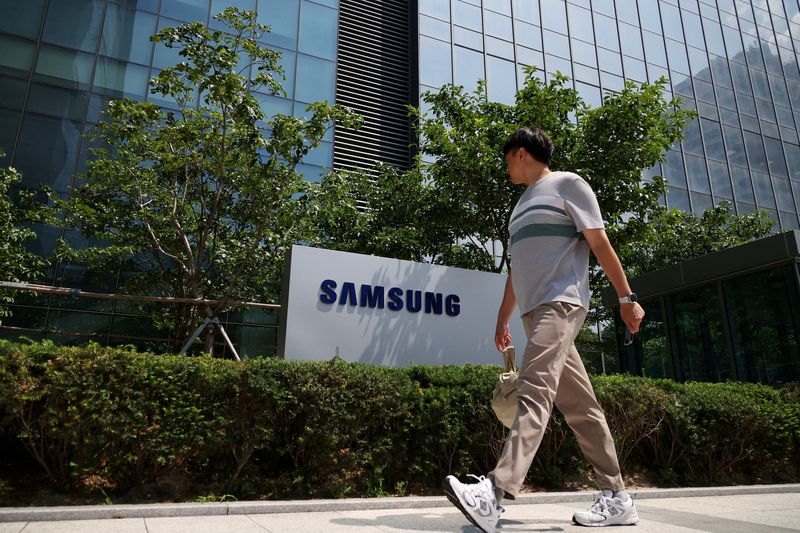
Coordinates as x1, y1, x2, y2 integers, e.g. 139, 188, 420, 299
42, 0, 105, 52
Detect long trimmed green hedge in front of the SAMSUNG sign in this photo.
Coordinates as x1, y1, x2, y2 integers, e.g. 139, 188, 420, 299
0, 341, 800, 499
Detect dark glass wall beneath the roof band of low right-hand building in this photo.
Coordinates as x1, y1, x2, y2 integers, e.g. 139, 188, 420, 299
616, 263, 800, 384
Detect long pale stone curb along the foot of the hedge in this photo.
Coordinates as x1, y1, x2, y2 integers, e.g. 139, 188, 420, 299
0, 484, 800, 523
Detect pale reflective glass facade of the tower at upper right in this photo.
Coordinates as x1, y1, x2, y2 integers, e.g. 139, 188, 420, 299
419, 0, 800, 229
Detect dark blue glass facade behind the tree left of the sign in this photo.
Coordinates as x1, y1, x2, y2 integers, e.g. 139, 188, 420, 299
0, 0, 339, 354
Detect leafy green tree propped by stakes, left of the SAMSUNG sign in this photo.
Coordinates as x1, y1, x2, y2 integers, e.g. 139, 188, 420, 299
62, 8, 360, 351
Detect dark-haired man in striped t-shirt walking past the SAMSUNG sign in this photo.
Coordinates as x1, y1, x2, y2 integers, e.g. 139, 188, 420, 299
443, 128, 644, 533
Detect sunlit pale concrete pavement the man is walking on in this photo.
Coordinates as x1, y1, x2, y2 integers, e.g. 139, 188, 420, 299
0, 485, 800, 533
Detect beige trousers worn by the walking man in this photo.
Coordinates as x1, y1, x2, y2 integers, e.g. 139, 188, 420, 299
488, 302, 625, 499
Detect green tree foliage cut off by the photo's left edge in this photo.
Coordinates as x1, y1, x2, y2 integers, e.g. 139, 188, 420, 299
0, 150, 48, 324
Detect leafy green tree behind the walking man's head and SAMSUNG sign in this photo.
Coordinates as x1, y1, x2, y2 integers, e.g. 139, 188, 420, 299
316, 68, 693, 272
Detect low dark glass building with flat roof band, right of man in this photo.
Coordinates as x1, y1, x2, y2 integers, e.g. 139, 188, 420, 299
604, 231, 800, 384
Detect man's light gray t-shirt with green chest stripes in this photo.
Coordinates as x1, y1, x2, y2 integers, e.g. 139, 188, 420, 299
508, 172, 605, 315
